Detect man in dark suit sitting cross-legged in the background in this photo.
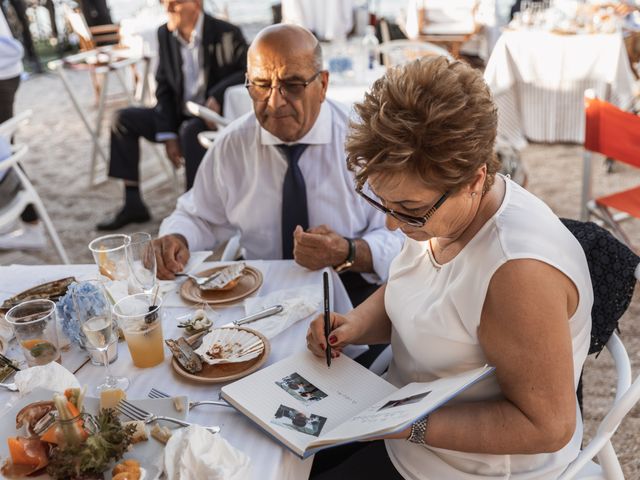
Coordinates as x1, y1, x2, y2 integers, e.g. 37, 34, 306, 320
97, 0, 247, 230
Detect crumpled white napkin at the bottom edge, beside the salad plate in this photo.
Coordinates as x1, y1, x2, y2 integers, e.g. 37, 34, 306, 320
164, 425, 251, 480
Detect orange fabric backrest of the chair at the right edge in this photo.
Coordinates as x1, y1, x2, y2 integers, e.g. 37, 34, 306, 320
584, 91, 640, 167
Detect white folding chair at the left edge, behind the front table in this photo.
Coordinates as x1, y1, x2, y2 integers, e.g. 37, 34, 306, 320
0, 110, 69, 264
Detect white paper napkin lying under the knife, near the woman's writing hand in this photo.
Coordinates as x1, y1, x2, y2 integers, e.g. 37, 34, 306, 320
244, 286, 322, 338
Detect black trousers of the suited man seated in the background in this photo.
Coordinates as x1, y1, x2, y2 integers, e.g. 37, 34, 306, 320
109, 107, 207, 190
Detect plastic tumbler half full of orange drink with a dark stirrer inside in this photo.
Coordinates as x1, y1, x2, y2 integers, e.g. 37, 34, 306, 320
113, 293, 164, 368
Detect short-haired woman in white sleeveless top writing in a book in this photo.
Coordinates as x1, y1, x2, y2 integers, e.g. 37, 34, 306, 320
307, 57, 593, 480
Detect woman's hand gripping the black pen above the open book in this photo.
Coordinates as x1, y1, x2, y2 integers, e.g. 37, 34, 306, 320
307, 312, 360, 358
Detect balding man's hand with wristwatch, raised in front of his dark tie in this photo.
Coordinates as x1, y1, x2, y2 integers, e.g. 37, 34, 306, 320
293, 225, 349, 270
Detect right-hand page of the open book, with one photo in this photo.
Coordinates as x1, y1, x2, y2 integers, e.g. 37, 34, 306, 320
308, 366, 493, 450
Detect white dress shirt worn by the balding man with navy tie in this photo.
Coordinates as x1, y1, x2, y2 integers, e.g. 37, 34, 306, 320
160, 100, 403, 282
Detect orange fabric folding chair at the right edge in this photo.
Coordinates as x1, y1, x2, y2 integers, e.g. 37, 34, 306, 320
581, 90, 640, 246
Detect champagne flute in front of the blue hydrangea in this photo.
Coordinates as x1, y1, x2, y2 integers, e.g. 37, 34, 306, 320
72, 280, 129, 393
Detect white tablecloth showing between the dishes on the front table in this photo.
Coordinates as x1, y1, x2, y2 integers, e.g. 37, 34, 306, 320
0, 260, 351, 480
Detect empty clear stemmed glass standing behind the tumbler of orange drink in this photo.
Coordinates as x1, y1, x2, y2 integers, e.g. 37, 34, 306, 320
125, 232, 156, 293
